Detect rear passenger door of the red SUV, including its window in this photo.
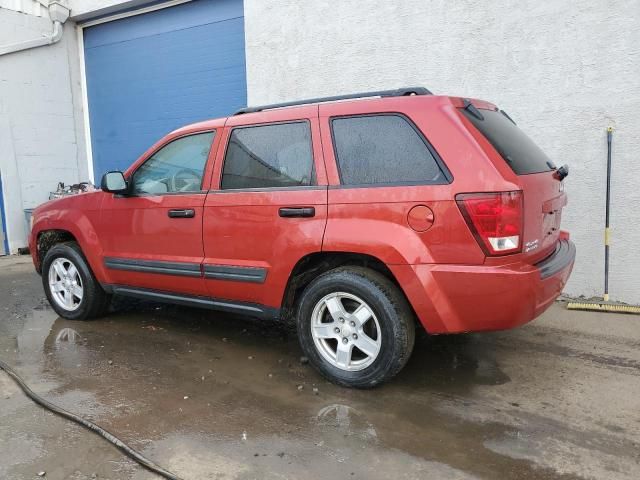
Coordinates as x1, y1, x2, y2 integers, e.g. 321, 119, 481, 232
203, 106, 327, 308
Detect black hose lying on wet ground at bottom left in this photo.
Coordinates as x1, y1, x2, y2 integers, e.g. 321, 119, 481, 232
0, 360, 181, 480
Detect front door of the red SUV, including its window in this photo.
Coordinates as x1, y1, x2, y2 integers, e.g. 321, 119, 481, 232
98, 131, 220, 295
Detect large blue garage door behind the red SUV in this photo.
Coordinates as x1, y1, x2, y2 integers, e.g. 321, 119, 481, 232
84, 0, 247, 182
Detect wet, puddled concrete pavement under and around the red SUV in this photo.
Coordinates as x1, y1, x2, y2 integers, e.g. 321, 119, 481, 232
0, 253, 640, 480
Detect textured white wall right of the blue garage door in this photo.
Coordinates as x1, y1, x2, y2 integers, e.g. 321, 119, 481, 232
245, 0, 640, 302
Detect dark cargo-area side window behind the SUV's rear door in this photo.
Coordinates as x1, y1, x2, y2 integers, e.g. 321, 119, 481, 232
331, 114, 447, 185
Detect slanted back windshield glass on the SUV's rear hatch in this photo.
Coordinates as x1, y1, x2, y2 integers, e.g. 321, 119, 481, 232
461, 108, 555, 175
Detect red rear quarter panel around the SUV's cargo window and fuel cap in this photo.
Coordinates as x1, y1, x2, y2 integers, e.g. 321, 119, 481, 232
320, 97, 518, 264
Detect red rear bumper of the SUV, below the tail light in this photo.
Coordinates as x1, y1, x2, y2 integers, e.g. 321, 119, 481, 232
389, 238, 576, 334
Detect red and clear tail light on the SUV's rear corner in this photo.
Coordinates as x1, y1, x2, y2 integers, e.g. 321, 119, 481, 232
456, 191, 523, 255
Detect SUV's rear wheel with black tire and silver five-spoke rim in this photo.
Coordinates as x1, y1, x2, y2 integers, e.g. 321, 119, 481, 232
296, 267, 415, 388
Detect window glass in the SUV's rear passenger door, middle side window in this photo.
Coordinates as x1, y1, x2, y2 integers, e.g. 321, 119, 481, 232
221, 122, 315, 189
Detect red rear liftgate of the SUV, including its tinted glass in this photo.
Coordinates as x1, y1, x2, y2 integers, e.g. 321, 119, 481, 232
460, 102, 567, 263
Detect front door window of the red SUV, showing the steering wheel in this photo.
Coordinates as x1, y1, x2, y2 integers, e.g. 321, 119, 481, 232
131, 132, 215, 195
